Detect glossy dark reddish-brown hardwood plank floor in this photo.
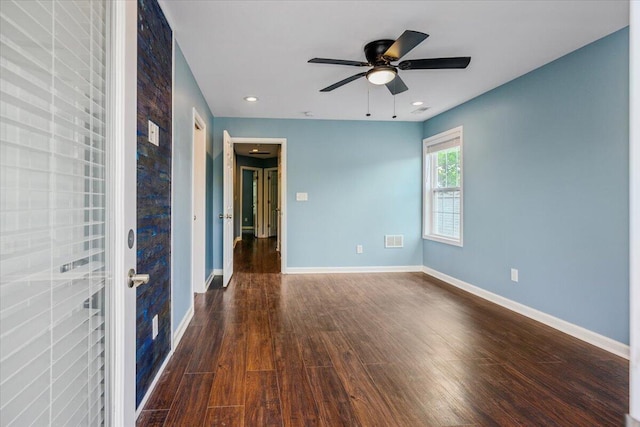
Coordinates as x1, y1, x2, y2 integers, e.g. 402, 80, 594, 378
138, 239, 629, 427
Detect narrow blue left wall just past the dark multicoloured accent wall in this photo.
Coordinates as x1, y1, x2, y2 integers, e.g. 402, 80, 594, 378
171, 43, 213, 332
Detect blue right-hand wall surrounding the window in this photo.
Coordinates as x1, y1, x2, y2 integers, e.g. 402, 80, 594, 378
423, 29, 629, 343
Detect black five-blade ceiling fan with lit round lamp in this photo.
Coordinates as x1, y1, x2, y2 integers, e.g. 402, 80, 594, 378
309, 30, 471, 95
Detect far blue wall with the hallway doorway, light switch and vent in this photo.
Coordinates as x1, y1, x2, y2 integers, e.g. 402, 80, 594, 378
213, 117, 422, 268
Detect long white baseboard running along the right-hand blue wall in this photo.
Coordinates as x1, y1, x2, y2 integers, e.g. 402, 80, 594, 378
422, 267, 629, 360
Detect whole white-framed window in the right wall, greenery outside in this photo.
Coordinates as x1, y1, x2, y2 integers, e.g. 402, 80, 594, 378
422, 126, 463, 246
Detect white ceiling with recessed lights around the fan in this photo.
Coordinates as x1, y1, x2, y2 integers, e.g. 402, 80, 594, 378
160, 0, 629, 121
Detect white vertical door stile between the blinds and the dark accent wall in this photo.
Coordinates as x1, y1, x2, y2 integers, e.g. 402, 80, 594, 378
110, 2, 138, 426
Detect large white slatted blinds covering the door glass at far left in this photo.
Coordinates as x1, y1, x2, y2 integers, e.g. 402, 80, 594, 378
0, 0, 107, 426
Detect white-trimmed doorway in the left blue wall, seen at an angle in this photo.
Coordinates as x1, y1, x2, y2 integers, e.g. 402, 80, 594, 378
191, 107, 207, 293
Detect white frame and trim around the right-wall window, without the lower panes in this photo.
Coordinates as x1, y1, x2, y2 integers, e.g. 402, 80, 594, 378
422, 126, 464, 247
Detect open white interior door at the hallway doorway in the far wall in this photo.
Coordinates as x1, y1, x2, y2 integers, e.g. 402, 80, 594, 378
220, 130, 233, 287
